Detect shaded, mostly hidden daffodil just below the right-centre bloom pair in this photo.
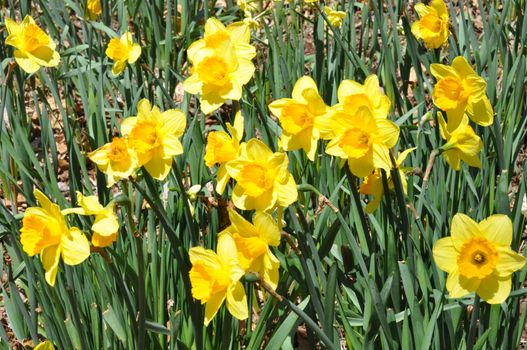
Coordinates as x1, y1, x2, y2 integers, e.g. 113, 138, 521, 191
359, 147, 415, 213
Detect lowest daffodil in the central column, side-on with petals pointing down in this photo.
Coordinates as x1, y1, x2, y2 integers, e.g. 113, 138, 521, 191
189, 234, 248, 326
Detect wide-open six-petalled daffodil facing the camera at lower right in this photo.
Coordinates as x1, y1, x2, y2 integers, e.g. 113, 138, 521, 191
433, 213, 525, 304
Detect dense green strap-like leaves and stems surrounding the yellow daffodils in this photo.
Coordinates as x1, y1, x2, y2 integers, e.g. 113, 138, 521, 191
0, 0, 527, 349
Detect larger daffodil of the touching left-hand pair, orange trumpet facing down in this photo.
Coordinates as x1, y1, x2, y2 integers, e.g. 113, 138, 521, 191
121, 99, 187, 180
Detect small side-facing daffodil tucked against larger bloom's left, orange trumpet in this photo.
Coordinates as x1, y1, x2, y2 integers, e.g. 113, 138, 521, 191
88, 137, 137, 187
